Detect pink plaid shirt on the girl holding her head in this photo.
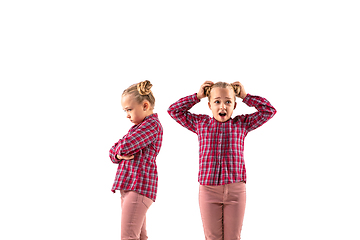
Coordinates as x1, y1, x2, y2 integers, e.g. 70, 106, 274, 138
168, 94, 276, 185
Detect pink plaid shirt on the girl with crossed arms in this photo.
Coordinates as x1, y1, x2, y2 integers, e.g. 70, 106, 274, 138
109, 113, 163, 202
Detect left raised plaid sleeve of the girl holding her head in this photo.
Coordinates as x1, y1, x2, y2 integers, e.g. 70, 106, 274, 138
168, 93, 202, 133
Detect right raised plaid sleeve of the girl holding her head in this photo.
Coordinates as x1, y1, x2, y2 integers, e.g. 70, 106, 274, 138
241, 94, 276, 132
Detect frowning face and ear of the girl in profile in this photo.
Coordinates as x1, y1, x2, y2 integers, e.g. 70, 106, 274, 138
121, 95, 151, 125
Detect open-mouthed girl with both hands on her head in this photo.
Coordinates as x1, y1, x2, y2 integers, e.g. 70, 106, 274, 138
168, 81, 276, 240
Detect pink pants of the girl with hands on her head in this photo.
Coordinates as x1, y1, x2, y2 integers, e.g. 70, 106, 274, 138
199, 182, 246, 240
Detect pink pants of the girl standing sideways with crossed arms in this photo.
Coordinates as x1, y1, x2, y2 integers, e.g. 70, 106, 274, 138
120, 190, 153, 240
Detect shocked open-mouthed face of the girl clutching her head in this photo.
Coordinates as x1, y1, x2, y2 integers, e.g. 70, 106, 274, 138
209, 87, 236, 122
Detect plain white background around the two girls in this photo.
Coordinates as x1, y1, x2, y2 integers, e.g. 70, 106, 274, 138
0, 0, 360, 240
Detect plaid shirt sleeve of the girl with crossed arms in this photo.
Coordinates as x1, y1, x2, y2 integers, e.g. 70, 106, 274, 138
109, 119, 159, 163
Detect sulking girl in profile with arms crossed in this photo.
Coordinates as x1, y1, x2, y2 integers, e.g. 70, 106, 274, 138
109, 80, 163, 240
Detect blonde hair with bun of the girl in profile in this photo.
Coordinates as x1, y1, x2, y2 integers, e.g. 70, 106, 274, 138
122, 80, 155, 108
